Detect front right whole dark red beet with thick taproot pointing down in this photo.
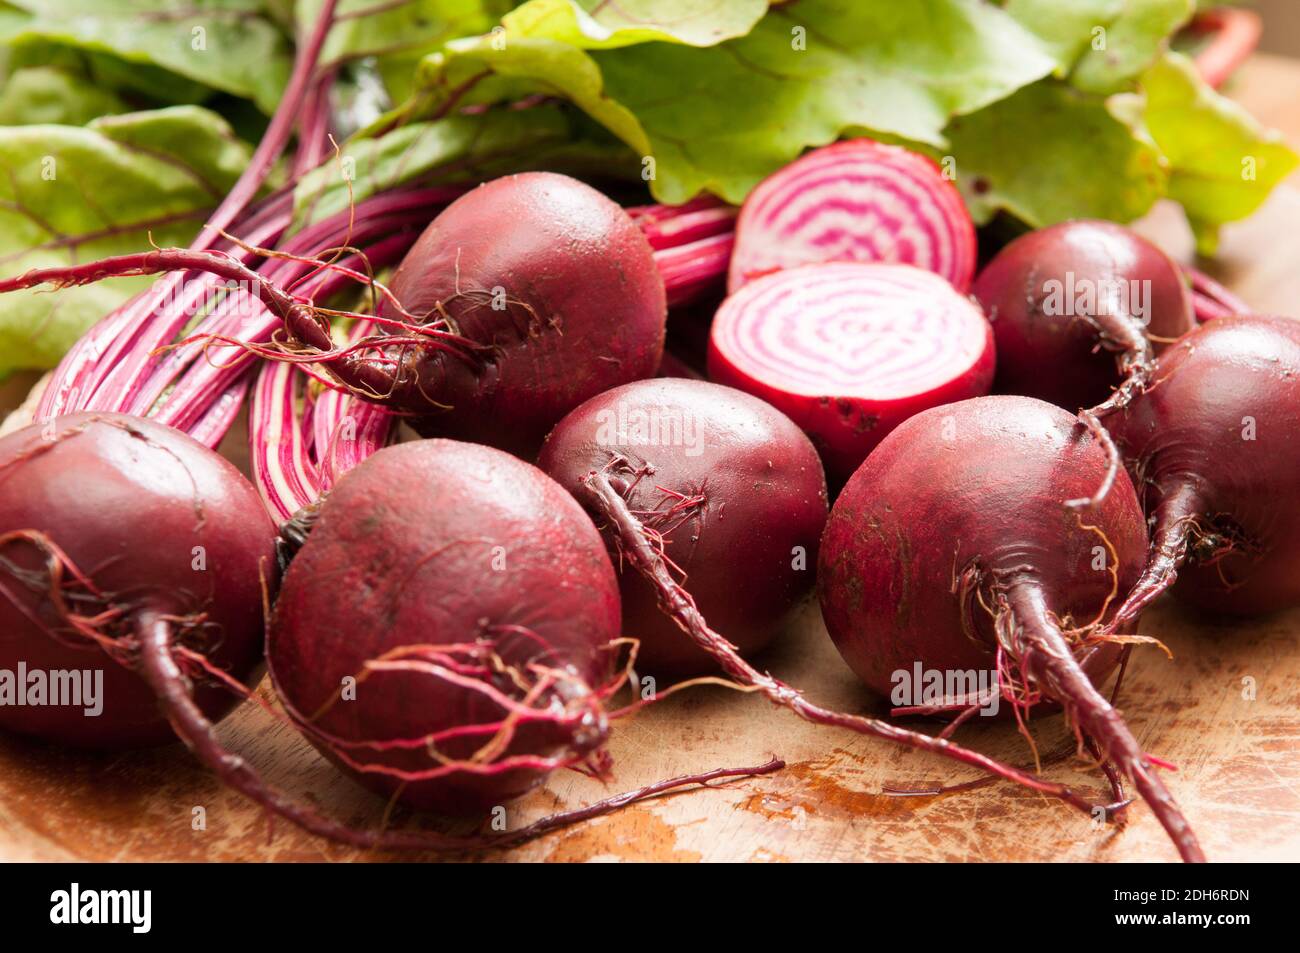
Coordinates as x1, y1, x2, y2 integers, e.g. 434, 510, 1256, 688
818, 397, 1203, 859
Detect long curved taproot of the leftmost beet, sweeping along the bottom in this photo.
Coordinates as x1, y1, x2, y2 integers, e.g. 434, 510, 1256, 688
137, 611, 785, 852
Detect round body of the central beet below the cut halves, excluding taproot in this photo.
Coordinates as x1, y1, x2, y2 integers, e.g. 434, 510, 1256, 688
537, 378, 827, 676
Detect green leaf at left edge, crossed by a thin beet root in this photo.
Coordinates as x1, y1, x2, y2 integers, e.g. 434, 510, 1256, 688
0, 107, 250, 377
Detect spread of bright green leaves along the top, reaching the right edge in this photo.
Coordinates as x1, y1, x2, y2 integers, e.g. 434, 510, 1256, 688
385, 0, 1295, 241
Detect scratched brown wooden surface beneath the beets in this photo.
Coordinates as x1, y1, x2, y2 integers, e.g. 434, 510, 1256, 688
0, 64, 1300, 861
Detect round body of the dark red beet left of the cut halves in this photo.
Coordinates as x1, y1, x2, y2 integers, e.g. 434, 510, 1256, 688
358, 172, 667, 452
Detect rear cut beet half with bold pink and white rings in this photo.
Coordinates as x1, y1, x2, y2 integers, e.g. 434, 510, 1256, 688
727, 139, 976, 291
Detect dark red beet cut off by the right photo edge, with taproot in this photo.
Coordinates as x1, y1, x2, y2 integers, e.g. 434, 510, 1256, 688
1108, 317, 1300, 624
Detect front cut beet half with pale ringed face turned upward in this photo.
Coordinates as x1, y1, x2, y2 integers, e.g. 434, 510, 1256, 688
709, 263, 993, 481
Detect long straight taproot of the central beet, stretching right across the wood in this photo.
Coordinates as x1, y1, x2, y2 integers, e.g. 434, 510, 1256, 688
585, 471, 1122, 816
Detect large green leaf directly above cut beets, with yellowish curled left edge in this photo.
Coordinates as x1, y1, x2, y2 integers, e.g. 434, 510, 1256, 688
420, 0, 1056, 202
